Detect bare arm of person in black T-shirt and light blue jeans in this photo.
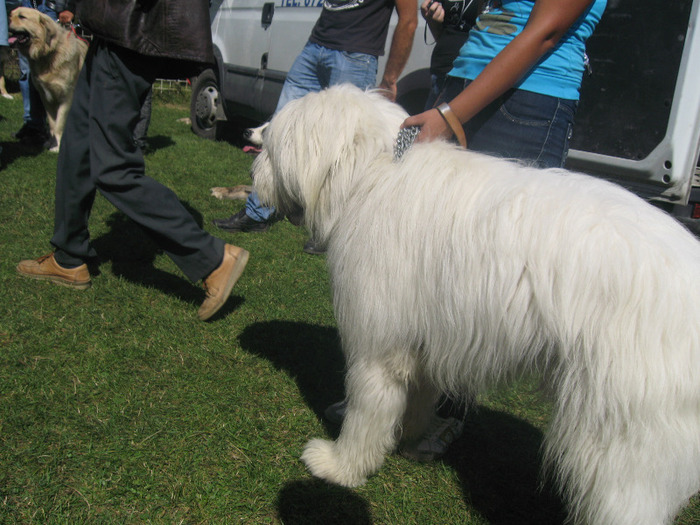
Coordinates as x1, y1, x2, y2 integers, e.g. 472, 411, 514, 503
379, 0, 418, 100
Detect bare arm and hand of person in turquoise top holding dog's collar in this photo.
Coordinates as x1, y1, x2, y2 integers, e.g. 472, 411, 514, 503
403, 0, 593, 142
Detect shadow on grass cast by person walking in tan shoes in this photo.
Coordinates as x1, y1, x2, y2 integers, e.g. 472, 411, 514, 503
90, 202, 243, 314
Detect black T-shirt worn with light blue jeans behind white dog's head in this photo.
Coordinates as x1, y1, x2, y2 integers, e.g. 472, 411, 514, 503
309, 0, 394, 56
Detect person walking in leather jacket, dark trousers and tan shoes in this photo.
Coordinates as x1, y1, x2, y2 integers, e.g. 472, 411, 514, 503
17, 0, 248, 320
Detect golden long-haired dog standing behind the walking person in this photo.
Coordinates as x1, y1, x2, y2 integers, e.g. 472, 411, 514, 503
9, 7, 88, 152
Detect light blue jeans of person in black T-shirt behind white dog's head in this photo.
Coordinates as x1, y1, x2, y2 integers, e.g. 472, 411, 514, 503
245, 42, 377, 222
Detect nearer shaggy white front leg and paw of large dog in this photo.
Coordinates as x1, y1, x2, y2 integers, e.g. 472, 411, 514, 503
301, 363, 408, 487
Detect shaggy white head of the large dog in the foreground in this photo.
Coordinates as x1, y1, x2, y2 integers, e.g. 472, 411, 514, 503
252, 84, 408, 242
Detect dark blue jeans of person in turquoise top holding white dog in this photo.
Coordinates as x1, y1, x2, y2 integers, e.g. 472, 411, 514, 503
438, 77, 578, 168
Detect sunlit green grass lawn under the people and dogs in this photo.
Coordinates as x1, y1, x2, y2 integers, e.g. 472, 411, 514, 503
0, 88, 700, 525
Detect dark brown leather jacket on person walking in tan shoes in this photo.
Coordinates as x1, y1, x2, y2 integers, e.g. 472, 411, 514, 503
76, 0, 214, 78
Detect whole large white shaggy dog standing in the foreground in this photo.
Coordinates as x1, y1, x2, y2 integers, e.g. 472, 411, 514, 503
253, 86, 700, 525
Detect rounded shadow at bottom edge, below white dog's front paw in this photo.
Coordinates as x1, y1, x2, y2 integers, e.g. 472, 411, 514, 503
277, 479, 372, 525
